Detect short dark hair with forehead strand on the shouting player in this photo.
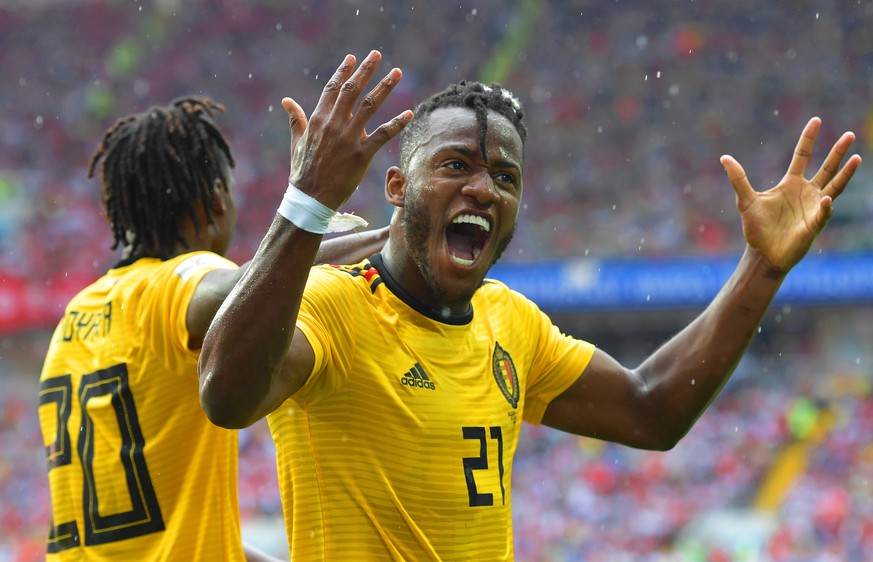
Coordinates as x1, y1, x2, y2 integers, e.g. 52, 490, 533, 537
400, 80, 527, 170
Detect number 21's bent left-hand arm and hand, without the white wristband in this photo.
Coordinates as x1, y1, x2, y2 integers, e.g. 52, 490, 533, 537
200, 51, 412, 428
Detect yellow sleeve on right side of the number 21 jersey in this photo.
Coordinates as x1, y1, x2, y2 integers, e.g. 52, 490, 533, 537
517, 295, 595, 425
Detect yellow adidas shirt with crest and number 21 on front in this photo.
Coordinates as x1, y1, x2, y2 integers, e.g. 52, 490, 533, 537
268, 254, 594, 561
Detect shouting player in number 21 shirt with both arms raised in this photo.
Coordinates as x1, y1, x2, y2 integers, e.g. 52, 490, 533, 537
200, 51, 860, 560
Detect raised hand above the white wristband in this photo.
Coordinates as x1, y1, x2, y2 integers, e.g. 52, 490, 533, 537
282, 51, 412, 209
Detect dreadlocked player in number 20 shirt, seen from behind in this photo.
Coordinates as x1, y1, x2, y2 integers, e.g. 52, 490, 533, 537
39, 97, 385, 562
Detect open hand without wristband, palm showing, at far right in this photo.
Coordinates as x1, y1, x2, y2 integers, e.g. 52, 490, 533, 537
721, 117, 861, 273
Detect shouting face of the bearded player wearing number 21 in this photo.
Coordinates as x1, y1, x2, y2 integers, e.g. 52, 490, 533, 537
402, 108, 523, 310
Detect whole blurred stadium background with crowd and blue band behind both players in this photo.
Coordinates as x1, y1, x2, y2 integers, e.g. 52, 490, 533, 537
0, 0, 873, 562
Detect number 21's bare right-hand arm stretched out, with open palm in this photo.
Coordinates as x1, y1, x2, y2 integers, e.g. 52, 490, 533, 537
543, 118, 861, 450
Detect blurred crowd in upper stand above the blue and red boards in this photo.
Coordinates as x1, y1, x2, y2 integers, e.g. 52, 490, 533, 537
0, 0, 873, 280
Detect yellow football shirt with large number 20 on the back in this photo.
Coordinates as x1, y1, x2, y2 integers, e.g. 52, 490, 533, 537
39, 252, 244, 562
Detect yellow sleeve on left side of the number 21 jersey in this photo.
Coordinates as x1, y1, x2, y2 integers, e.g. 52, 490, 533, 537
293, 266, 366, 407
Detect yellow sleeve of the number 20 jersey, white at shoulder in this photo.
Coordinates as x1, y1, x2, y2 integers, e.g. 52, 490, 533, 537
137, 252, 238, 373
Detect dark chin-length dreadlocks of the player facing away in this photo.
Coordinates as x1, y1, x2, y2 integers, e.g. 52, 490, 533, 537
88, 96, 236, 259
